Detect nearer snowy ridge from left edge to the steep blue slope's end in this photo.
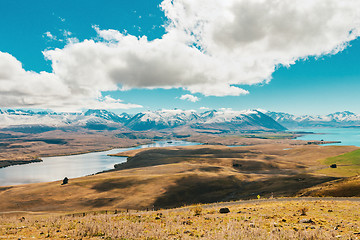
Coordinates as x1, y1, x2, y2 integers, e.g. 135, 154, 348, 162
0, 109, 285, 131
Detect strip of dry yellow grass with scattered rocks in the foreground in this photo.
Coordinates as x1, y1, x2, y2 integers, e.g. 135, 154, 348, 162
0, 199, 360, 239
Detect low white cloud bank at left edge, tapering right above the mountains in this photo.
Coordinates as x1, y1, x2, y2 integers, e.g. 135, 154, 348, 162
0, 52, 141, 111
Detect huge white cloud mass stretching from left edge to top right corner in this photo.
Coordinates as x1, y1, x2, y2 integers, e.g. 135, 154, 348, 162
0, 0, 360, 109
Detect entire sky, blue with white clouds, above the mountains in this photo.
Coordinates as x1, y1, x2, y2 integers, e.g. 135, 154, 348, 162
0, 0, 360, 115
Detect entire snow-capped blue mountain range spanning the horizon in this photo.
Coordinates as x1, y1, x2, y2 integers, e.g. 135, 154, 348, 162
0, 109, 360, 131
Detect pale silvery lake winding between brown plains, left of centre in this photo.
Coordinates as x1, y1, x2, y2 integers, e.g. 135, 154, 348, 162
0, 141, 199, 186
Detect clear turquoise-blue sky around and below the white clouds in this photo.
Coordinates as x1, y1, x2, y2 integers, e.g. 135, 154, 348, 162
0, 0, 360, 114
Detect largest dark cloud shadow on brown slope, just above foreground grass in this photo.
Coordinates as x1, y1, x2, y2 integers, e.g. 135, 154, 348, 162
154, 174, 337, 208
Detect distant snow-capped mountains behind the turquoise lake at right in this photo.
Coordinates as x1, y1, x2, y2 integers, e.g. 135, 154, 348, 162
266, 111, 360, 128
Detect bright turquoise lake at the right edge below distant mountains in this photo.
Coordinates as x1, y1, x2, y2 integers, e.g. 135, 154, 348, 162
291, 128, 360, 147
